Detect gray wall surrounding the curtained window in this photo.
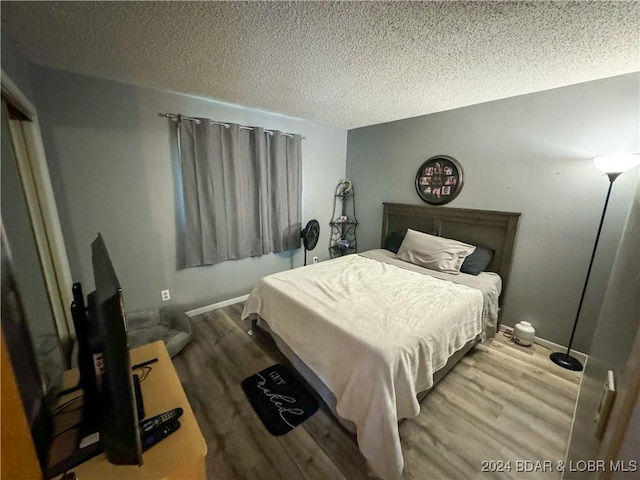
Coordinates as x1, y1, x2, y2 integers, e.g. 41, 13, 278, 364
30, 66, 347, 311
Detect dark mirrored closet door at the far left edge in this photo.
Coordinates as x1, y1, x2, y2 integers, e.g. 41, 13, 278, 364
0, 101, 65, 476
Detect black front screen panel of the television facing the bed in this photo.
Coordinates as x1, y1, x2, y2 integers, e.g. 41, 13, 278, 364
91, 234, 142, 465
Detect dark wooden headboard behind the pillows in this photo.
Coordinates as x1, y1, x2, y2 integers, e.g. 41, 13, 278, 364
381, 203, 520, 304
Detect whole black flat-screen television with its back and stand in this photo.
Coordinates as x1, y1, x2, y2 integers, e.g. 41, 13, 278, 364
46, 234, 142, 477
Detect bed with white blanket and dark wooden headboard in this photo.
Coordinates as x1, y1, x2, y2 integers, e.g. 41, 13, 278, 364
242, 203, 519, 478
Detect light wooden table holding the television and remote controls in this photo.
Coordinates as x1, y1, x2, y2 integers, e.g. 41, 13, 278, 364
52, 341, 207, 480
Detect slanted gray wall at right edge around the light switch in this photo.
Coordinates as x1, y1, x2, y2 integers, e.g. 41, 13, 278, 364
566, 175, 640, 478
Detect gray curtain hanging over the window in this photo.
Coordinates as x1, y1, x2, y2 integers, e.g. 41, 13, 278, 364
178, 119, 302, 267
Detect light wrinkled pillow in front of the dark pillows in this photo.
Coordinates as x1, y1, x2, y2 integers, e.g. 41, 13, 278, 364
398, 229, 476, 274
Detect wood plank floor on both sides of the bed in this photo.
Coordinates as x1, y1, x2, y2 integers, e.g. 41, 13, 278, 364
174, 304, 580, 480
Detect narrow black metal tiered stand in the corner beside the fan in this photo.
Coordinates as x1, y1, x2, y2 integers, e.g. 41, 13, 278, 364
329, 178, 358, 258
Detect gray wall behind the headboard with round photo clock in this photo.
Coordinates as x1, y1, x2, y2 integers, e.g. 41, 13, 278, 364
347, 73, 640, 351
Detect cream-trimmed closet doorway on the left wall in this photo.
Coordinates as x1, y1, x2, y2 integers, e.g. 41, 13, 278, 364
0, 72, 74, 360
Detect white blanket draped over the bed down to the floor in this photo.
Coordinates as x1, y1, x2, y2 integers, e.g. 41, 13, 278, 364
243, 255, 492, 478
